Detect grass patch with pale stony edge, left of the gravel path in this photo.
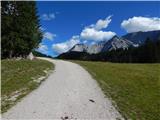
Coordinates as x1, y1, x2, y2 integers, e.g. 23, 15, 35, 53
1, 59, 54, 113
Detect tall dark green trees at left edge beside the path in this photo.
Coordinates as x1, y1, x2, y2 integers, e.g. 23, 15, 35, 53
1, 1, 42, 58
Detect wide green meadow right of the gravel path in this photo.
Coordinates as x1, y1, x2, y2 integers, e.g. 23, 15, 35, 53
74, 61, 160, 120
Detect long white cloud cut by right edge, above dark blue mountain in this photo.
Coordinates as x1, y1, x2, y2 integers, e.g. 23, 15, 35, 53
121, 16, 160, 33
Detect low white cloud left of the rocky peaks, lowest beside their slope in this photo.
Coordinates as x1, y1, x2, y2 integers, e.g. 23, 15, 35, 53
52, 36, 80, 53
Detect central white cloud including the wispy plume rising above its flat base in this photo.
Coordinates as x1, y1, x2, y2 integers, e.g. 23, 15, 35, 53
80, 15, 116, 41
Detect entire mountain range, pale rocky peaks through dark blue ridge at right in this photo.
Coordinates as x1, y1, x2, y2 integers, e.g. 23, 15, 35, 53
58, 30, 160, 54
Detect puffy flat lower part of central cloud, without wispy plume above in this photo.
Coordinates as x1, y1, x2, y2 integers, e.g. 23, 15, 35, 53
81, 28, 116, 41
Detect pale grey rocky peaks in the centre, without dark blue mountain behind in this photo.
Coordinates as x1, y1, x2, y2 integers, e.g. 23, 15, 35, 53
68, 36, 136, 54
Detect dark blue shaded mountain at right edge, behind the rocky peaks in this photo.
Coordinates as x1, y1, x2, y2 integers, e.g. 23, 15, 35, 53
122, 30, 160, 45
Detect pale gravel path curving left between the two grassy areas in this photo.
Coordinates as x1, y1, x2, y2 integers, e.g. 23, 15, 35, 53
2, 58, 121, 120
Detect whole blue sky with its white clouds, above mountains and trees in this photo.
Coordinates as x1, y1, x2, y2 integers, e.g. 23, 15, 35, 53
37, 1, 160, 56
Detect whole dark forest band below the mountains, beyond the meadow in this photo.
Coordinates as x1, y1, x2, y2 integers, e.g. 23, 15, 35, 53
58, 39, 160, 63
